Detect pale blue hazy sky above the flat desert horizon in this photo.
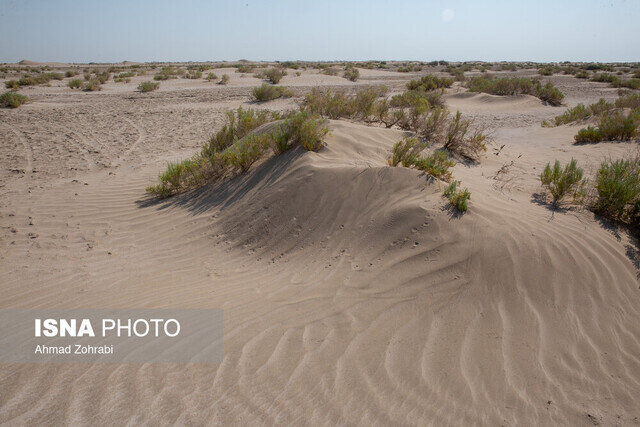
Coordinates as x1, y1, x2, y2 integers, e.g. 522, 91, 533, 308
0, 0, 640, 62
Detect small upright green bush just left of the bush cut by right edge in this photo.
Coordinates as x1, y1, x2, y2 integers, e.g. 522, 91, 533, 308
540, 159, 585, 206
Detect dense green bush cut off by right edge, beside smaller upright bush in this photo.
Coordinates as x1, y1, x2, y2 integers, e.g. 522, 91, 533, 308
592, 157, 640, 223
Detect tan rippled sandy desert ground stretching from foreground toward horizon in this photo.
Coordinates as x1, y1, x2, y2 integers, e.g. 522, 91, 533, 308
0, 70, 640, 425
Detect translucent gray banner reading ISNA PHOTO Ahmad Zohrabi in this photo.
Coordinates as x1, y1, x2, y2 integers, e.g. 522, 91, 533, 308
0, 309, 223, 363
